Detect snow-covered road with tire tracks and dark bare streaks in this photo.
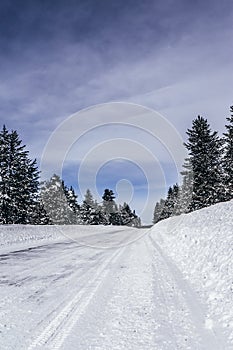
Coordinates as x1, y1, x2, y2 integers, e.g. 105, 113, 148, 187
0, 223, 230, 350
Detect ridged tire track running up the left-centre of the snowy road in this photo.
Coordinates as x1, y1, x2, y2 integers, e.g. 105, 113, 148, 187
28, 248, 125, 350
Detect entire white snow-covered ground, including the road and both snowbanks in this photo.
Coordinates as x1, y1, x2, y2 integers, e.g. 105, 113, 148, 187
0, 202, 233, 350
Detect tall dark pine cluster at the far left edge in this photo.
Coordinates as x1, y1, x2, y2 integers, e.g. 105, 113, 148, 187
0, 126, 39, 224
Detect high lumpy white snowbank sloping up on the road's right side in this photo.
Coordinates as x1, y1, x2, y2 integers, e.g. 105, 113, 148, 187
151, 201, 233, 348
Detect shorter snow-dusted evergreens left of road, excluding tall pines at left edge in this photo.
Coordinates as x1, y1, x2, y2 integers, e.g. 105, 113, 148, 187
40, 174, 141, 227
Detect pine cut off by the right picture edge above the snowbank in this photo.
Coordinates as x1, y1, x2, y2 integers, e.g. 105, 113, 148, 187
222, 106, 233, 200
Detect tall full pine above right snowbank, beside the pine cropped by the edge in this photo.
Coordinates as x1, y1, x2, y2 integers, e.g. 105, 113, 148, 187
185, 116, 223, 211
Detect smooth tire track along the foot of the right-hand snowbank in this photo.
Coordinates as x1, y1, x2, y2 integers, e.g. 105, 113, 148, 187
149, 234, 225, 350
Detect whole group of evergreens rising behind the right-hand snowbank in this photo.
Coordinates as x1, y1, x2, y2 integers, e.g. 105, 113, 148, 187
153, 106, 233, 224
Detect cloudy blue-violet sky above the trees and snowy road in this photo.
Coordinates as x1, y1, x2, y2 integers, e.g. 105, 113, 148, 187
0, 0, 233, 223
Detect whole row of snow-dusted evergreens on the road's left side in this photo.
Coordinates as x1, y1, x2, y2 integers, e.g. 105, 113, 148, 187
0, 126, 141, 226
